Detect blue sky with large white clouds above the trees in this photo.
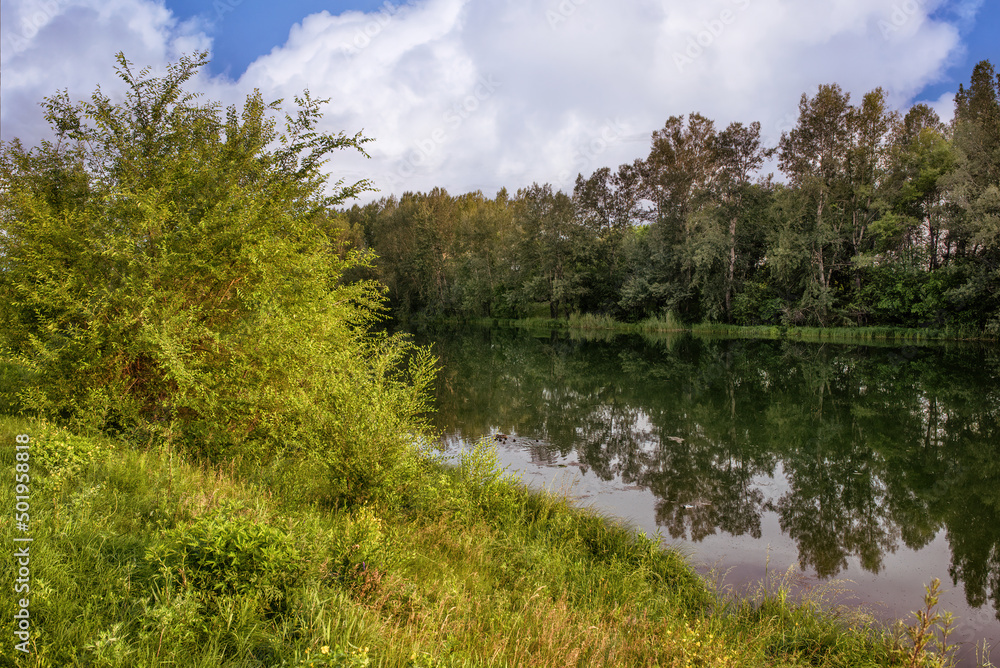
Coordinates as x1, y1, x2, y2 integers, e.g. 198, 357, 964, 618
0, 0, 1000, 202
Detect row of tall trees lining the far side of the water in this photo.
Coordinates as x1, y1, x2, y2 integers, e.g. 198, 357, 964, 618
336, 61, 1000, 335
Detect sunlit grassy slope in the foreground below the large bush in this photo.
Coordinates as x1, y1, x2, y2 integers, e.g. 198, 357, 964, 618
0, 419, 968, 668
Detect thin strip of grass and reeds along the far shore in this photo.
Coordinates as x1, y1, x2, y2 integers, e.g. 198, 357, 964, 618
450, 313, 997, 343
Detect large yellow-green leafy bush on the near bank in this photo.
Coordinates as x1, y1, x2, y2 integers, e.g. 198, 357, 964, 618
0, 54, 433, 499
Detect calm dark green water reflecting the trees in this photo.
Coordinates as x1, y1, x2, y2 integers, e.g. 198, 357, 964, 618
417, 329, 1000, 665
